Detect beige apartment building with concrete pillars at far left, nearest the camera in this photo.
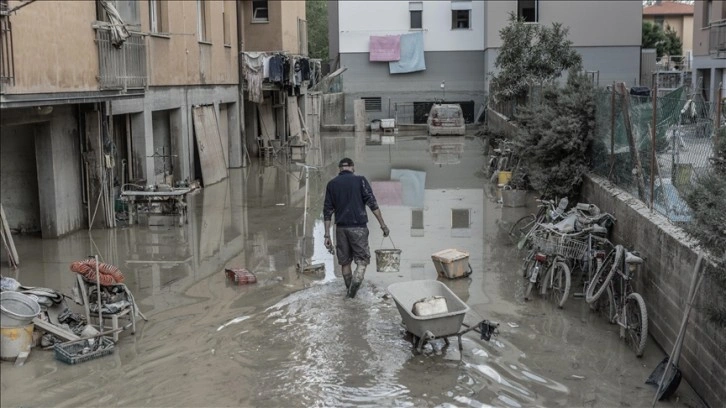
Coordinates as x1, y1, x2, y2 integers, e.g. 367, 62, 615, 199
0, 0, 242, 238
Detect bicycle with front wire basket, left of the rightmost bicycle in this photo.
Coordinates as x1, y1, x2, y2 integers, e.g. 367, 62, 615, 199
524, 226, 587, 309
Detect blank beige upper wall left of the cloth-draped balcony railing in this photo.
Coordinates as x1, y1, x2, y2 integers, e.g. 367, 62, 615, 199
3, 1, 98, 94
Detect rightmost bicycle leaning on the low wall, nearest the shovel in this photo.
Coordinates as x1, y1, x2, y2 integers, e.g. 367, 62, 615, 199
585, 245, 648, 357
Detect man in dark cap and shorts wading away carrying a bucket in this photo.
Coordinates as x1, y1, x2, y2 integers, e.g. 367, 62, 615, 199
323, 157, 390, 298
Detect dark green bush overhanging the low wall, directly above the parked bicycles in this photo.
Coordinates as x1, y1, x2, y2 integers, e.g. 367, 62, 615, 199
515, 69, 595, 199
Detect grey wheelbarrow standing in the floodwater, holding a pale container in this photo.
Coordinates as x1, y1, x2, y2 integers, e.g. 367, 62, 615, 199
388, 280, 499, 353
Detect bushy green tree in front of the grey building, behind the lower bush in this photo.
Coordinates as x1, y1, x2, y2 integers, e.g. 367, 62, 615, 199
491, 13, 582, 101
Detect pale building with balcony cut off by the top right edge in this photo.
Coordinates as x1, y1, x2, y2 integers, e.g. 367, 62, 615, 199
693, 0, 726, 101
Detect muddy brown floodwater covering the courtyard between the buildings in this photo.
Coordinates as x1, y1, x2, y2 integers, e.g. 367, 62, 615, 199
0, 133, 702, 407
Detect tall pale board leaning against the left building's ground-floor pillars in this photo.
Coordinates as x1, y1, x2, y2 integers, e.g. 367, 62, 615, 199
192, 105, 227, 186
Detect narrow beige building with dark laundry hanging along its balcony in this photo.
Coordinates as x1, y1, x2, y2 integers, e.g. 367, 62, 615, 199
241, 0, 321, 156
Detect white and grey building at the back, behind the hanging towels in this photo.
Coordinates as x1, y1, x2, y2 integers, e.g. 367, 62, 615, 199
329, 0, 642, 123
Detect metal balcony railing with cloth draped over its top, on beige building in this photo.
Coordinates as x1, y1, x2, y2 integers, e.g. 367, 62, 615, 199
96, 28, 147, 90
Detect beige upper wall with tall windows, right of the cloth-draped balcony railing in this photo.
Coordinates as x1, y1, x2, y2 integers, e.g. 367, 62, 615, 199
144, 0, 239, 86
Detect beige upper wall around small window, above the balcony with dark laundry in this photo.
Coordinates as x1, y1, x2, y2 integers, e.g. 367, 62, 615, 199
247, 0, 288, 51
